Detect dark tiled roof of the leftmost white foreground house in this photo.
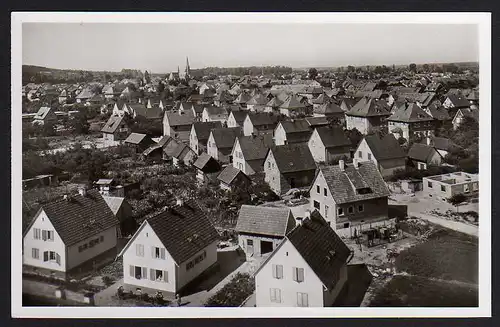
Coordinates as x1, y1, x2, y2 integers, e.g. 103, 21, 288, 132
26, 190, 119, 246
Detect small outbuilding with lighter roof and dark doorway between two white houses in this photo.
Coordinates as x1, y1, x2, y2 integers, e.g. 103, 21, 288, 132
235, 208, 296, 257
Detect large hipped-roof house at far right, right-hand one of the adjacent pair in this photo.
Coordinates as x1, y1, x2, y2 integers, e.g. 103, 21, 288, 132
387, 103, 436, 141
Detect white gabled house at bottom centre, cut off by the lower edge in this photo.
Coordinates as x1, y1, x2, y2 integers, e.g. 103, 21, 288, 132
254, 211, 352, 308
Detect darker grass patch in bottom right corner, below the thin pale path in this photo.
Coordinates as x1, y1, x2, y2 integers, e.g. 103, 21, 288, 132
370, 276, 478, 307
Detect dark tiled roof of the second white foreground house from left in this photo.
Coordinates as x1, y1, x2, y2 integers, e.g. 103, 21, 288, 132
142, 200, 219, 265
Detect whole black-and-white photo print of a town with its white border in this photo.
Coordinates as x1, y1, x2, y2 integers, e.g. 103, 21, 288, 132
12, 12, 491, 318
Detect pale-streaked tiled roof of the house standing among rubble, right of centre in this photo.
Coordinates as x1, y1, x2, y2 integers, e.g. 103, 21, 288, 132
319, 161, 390, 204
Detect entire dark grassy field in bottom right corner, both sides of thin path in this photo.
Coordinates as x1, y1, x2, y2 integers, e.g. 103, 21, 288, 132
370, 229, 478, 307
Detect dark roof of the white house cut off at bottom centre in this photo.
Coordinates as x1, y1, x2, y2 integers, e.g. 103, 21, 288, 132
286, 210, 351, 290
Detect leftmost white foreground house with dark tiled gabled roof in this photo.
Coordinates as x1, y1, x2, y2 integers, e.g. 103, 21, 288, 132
23, 188, 119, 279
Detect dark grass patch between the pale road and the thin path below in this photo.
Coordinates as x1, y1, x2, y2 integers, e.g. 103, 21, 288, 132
396, 229, 479, 284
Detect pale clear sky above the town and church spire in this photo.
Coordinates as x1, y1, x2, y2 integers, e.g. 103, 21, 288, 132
22, 23, 479, 73
